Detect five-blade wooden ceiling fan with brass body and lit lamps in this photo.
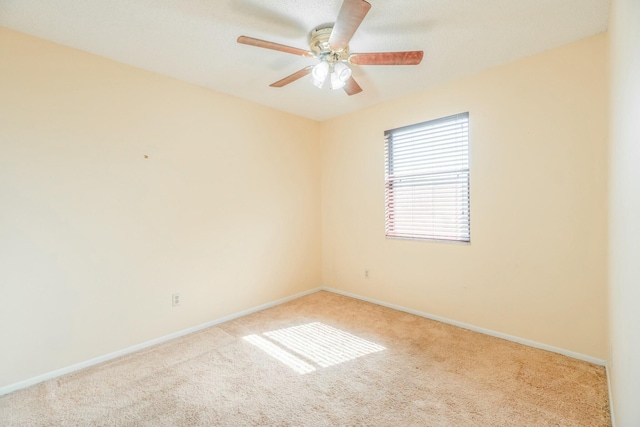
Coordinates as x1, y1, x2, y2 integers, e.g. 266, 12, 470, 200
237, 0, 423, 95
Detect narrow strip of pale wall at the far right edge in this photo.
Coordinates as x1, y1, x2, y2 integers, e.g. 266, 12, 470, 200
609, 0, 640, 427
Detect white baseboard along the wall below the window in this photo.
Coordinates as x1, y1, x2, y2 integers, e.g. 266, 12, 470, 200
321, 286, 606, 366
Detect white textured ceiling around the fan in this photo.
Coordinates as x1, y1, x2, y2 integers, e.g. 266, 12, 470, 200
0, 0, 609, 120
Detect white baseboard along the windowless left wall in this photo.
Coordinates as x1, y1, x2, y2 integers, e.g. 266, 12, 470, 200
0, 288, 322, 396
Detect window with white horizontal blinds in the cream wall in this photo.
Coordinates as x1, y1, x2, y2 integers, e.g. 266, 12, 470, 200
384, 113, 470, 242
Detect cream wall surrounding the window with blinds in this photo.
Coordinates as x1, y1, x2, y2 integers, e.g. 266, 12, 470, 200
321, 35, 608, 359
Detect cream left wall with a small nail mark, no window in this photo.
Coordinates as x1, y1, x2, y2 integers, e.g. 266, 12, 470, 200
0, 28, 321, 387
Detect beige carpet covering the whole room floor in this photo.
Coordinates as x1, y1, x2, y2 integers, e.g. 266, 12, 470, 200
0, 292, 610, 427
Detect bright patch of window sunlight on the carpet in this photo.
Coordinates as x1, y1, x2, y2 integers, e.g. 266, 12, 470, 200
244, 322, 386, 374
